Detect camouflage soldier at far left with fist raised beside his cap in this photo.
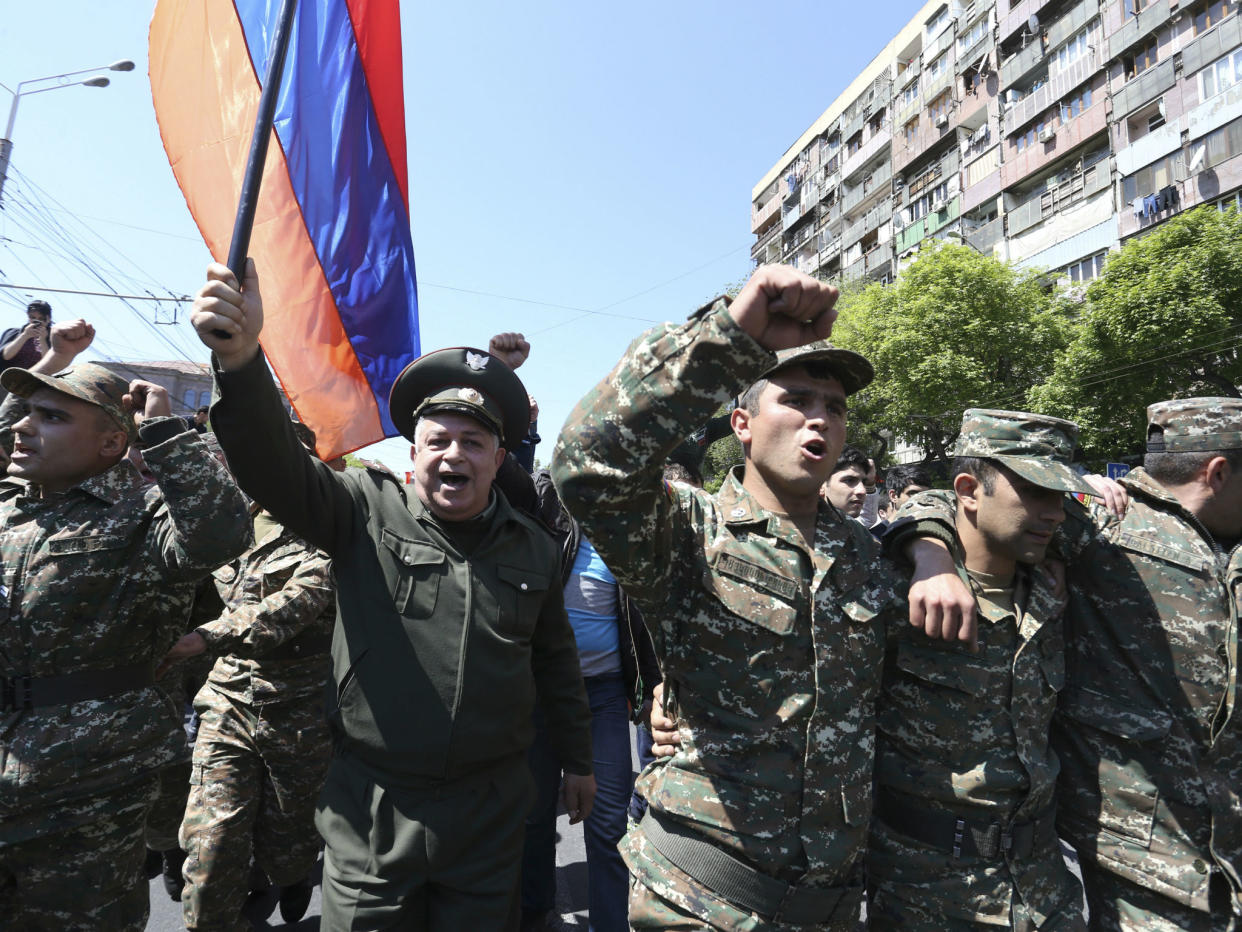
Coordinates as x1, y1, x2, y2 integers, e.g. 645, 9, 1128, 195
0, 321, 250, 932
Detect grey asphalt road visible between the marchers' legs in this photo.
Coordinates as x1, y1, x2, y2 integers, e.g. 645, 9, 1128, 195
147, 727, 638, 932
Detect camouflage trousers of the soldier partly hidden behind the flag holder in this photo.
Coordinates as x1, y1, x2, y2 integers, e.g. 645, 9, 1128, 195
180, 683, 332, 930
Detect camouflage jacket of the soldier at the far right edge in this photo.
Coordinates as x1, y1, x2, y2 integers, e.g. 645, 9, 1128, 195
889, 468, 1242, 911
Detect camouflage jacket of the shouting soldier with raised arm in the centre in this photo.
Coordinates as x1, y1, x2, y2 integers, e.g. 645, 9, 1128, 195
553, 302, 897, 886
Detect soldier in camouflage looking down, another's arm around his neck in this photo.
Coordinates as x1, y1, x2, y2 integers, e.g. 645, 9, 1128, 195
867, 409, 1092, 932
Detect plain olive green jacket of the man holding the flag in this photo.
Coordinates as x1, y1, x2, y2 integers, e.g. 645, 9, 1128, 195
211, 354, 591, 790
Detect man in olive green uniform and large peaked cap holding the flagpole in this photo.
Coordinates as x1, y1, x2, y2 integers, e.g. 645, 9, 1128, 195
194, 266, 594, 932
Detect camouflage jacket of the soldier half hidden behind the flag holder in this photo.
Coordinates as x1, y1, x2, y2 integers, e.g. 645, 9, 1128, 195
195, 526, 337, 705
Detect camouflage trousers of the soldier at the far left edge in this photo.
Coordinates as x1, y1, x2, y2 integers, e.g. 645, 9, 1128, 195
0, 777, 155, 932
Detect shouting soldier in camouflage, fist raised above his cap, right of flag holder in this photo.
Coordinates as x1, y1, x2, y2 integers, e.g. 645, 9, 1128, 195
553, 267, 895, 930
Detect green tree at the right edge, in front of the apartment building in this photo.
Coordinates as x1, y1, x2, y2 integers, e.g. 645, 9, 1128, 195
1031, 208, 1242, 462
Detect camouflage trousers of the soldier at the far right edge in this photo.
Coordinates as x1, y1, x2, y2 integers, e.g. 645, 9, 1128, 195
1082, 861, 1242, 932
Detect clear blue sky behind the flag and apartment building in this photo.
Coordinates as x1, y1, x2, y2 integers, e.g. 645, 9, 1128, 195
0, 0, 922, 468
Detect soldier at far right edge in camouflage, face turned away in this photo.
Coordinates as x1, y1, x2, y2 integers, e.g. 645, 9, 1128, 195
912, 398, 1242, 932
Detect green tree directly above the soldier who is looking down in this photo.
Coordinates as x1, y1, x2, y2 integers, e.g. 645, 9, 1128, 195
832, 242, 1071, 459
